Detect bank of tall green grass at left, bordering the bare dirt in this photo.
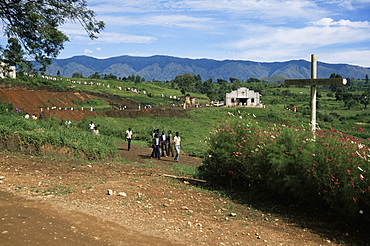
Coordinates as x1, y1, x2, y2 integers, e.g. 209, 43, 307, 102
0, 113, 118, 160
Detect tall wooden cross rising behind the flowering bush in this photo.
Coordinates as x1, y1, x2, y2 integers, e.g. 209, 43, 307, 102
284, 54, 347, 132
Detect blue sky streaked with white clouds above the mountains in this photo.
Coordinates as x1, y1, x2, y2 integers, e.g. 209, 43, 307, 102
4, 0, 370, 67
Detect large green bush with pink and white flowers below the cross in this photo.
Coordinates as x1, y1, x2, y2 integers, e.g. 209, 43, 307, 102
200, 112, 370, 220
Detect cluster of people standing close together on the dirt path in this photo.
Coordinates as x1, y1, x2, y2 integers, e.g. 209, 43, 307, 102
150, 129, 181, 162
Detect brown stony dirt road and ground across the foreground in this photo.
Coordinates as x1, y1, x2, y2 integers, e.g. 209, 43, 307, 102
0, 143, 367, 246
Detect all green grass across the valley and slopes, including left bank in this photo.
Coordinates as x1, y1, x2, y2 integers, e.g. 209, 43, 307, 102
0, 77, 370, 160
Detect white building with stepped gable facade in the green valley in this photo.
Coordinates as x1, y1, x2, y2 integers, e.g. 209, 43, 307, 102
226, 87, 262, 107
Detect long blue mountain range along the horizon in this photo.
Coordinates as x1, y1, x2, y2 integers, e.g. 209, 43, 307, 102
46, 55, 370, 81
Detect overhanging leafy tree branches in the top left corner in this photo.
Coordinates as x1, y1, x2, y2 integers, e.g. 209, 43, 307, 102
0, 0, 105, 70
